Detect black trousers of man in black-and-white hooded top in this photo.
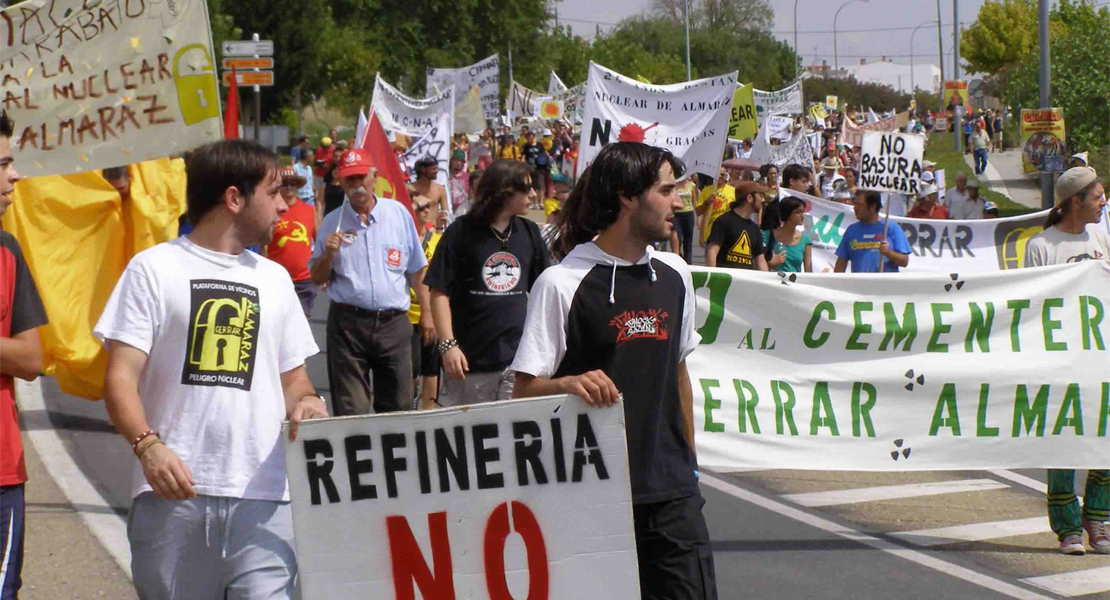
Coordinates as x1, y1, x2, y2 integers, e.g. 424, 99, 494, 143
632, 495, 717, 600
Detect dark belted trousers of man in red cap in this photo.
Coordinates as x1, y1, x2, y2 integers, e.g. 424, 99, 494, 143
327, 302, 413, 417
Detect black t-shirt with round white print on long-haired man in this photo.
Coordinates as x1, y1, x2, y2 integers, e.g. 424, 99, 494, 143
424, 214, 548, 373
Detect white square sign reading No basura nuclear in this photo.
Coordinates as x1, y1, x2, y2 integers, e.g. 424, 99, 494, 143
859, 131, 925, 196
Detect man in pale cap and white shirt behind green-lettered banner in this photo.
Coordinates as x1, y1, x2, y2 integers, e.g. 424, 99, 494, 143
1025, 166, 1110, 555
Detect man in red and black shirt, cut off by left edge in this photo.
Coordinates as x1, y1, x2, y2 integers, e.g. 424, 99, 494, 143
0, 110, 47, 598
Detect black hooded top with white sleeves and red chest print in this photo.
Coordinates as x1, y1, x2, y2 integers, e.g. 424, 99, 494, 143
511, 243, 700, 504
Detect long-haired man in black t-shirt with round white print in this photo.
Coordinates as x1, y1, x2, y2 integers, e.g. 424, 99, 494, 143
425, 161, 548, 406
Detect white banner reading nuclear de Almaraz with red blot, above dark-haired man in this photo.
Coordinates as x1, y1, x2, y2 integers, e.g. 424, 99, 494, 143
576, 62, 736, 177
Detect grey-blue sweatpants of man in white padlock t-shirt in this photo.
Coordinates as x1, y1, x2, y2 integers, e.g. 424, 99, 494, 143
128, 491, 296, 600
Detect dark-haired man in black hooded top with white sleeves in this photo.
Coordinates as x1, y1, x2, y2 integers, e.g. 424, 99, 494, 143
512, 142, 717, 600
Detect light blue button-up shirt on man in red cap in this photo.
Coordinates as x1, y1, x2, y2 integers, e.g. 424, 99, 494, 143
309, 197, 427, 311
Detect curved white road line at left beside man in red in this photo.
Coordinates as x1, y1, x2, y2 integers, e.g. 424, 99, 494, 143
16, 379, 132, 579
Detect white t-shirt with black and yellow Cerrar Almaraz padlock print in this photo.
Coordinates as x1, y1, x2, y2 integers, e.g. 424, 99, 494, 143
93, 237, 319, 500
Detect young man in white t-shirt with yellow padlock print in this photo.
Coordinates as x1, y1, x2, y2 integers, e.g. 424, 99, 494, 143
93, 140, 327, 600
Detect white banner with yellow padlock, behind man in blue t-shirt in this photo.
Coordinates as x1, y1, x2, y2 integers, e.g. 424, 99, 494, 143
781, 187, 1052, 273
